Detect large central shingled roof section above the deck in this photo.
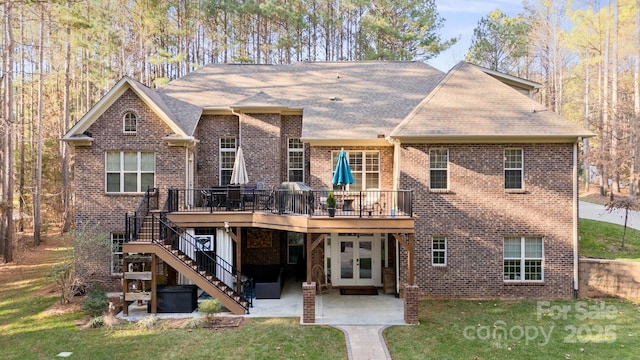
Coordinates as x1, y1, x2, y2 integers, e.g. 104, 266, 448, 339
158, 61, 445, 141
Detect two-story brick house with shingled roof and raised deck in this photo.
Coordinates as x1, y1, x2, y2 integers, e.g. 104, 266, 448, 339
63, 62, 592, 322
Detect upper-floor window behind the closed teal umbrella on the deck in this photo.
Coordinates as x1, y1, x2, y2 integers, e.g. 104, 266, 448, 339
332, 151, 380, 190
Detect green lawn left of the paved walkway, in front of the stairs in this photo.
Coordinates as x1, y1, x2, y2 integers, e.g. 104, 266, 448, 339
0, 239, 347, 360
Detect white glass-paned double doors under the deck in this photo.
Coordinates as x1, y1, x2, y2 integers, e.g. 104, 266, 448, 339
325, 234, 381, 286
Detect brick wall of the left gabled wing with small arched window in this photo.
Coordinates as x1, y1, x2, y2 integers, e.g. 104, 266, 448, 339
73, 90, 185, 290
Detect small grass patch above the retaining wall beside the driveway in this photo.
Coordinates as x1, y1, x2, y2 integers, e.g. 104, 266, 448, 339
578, 219, 640, 261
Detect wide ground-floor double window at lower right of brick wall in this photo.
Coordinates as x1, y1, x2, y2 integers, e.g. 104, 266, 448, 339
503, 237, 543, 281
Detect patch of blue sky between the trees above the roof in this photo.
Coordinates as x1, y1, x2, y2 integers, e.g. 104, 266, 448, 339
427, 0, 523, 72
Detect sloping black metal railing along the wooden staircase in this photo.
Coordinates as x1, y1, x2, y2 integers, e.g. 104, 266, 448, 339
126, 213, 252, 306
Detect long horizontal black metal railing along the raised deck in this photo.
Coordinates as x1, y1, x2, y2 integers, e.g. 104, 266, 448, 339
165, 188, 413, 218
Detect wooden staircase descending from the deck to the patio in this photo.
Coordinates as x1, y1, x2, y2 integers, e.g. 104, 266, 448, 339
122, 214, 251, 315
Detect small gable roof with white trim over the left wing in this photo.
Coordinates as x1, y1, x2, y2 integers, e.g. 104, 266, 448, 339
62, 76, 202, 143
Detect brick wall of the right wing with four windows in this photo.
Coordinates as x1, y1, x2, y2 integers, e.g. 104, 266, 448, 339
399, 144, 573, 298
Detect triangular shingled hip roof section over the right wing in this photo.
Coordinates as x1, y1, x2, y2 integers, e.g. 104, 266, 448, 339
391, 62, 593, 142
